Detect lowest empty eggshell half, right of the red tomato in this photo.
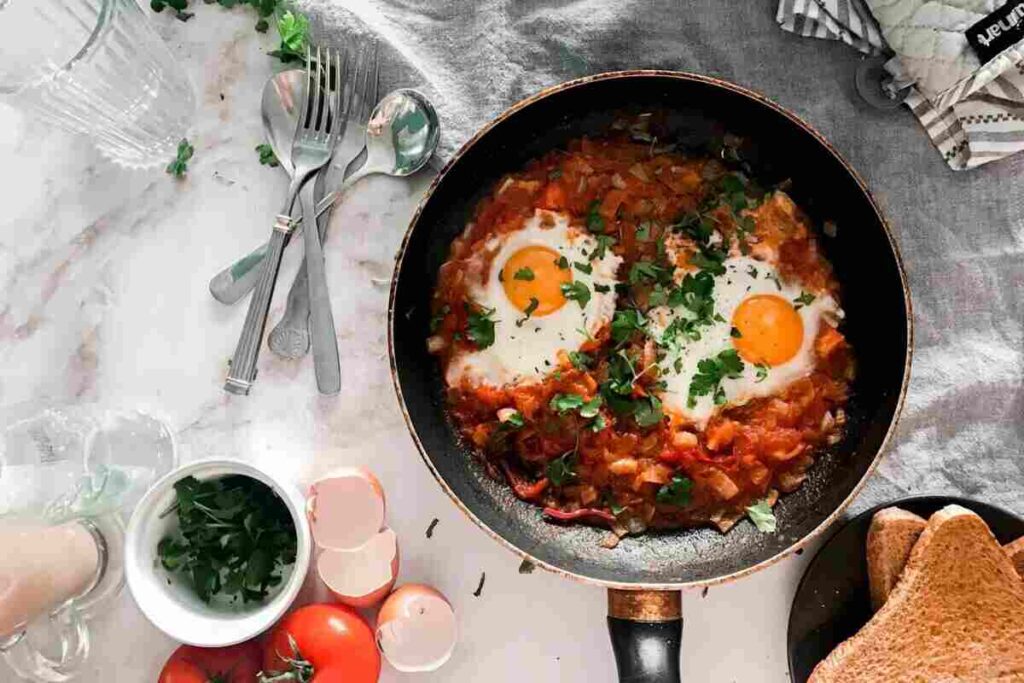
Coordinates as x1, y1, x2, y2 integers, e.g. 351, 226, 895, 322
377, 584, 458, 673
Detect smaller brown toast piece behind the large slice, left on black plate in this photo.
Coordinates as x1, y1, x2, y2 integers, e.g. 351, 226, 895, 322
867, 508, 928, 610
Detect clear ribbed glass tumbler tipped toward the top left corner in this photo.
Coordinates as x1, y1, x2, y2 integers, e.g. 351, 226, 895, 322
0, 0, 196, 168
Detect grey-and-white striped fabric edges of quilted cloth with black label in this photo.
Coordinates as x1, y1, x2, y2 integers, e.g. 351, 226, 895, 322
776, 0, 1024, 171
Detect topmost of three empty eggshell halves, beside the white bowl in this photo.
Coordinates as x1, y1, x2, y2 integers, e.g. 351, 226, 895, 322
306, 467, 385, 550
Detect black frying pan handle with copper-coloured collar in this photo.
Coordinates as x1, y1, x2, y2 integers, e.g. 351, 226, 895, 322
608, 589, 683, 683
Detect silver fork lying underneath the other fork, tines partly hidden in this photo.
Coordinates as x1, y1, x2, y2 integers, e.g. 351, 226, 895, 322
267, 45, 380, 359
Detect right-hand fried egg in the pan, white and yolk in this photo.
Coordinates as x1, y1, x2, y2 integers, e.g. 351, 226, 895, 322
648, 256, 843, 427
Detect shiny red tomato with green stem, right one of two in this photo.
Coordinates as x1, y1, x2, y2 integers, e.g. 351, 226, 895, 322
263, 604, 381, 683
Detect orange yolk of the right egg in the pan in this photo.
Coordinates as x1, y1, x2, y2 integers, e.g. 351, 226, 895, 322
732, 294, 804, 366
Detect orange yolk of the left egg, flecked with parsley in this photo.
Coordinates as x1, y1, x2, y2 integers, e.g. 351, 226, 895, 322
502, 246, 572, 317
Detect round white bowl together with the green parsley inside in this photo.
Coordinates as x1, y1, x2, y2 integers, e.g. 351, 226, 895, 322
125, 460, 312, 647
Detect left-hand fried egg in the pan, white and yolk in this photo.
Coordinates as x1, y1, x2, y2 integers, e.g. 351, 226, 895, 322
445, 210, 622, 387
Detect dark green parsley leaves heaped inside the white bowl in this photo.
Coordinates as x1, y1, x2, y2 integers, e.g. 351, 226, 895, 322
157, 475, 296, 603
